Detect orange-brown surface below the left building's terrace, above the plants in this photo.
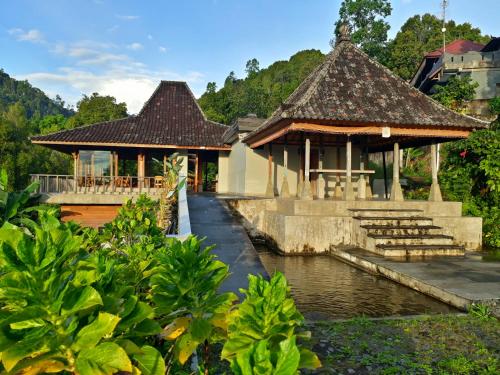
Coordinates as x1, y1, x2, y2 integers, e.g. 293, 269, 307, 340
61, 205, 121, 228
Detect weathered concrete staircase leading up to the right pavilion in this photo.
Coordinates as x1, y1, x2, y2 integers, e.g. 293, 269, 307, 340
349, 209, 465, 257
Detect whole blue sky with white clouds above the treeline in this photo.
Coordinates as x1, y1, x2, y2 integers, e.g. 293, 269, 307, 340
0, 0, 500, 113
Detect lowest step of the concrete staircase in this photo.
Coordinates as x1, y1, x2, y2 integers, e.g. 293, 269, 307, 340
374, 245, 465, 257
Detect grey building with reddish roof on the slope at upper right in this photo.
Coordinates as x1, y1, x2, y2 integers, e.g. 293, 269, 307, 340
411, 38, 500, 117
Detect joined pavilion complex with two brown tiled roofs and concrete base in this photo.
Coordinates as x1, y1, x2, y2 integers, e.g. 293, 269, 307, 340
32, 26, 487, 255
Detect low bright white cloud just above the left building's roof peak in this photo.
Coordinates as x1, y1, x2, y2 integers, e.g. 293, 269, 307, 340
21, 67, 203, 113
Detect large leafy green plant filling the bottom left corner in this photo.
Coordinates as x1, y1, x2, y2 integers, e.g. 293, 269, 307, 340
0, 215, 159, 375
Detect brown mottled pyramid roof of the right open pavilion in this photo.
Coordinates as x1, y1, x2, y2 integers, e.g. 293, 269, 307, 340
244, 40, 487, 143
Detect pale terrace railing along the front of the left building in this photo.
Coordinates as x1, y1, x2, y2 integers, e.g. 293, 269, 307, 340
31, 174, 163, 194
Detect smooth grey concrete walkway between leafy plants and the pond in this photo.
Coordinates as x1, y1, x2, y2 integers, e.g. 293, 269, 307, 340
188, 194, 267, 294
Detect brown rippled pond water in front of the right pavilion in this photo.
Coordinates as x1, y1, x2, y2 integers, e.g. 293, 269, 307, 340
255, 245, 457, 319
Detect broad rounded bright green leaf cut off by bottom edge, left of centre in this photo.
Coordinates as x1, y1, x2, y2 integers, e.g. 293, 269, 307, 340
75, 342, 132, 375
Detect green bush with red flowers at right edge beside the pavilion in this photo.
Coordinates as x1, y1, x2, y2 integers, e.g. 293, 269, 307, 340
440, 130, 500, 247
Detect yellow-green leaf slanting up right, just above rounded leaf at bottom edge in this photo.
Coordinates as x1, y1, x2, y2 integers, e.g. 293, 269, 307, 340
71, 312, 120, 352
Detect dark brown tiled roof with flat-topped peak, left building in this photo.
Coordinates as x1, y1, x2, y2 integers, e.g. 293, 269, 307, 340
31, 81, 227, 149
